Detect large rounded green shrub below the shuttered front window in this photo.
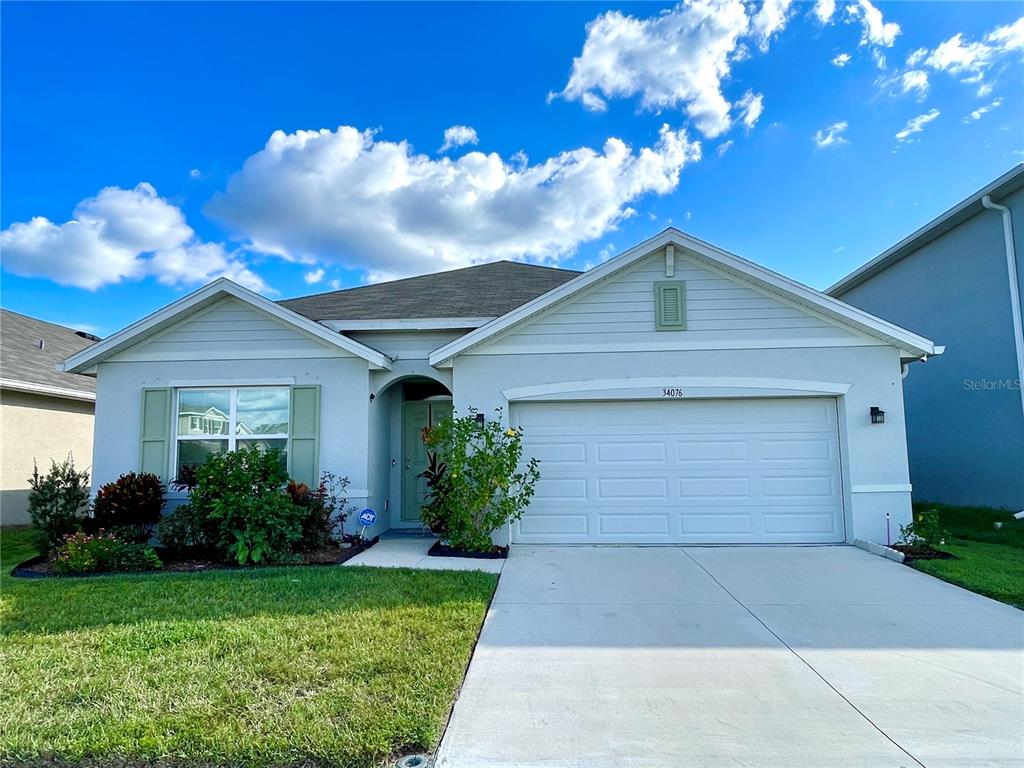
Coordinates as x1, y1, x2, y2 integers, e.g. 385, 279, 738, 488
191, 449, 306, 565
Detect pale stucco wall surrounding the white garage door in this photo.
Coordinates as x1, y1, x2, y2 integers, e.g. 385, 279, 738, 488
454, 346, 910, 542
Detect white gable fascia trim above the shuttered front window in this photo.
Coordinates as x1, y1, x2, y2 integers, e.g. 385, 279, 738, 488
56, 278, 391, 373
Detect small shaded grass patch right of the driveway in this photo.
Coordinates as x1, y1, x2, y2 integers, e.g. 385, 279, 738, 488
911, 504, 1024, 609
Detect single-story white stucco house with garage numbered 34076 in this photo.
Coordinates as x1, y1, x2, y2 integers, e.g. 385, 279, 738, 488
62, 229, 941, 544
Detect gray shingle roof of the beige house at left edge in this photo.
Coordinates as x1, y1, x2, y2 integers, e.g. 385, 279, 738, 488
0, 309, 98, 400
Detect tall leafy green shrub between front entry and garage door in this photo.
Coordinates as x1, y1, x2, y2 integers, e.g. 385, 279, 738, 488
426, 409, 541, 552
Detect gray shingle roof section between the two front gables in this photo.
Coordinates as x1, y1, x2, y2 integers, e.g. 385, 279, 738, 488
279, 261, 580, 321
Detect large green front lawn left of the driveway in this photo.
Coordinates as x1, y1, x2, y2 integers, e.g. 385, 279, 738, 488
0, 530, 497, 766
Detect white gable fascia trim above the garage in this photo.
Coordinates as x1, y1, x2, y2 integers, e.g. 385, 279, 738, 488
430, 227, 942, 366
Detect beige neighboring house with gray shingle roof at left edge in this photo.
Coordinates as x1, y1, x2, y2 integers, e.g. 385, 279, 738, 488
0, 309, 97, 525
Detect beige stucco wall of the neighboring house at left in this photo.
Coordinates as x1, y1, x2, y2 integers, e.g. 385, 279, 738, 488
0, 390, 93, 525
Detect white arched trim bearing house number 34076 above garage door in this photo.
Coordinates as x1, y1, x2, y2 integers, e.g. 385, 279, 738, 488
502, 376, 850, 402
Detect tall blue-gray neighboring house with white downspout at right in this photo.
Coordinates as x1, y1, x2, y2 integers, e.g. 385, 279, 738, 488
827, 164, 1024, 510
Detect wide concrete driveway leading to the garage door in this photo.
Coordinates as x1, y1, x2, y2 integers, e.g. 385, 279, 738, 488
437, 546, 1024, 768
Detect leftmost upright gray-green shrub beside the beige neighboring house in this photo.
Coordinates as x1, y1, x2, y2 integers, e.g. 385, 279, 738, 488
29, 455, 89, 555
